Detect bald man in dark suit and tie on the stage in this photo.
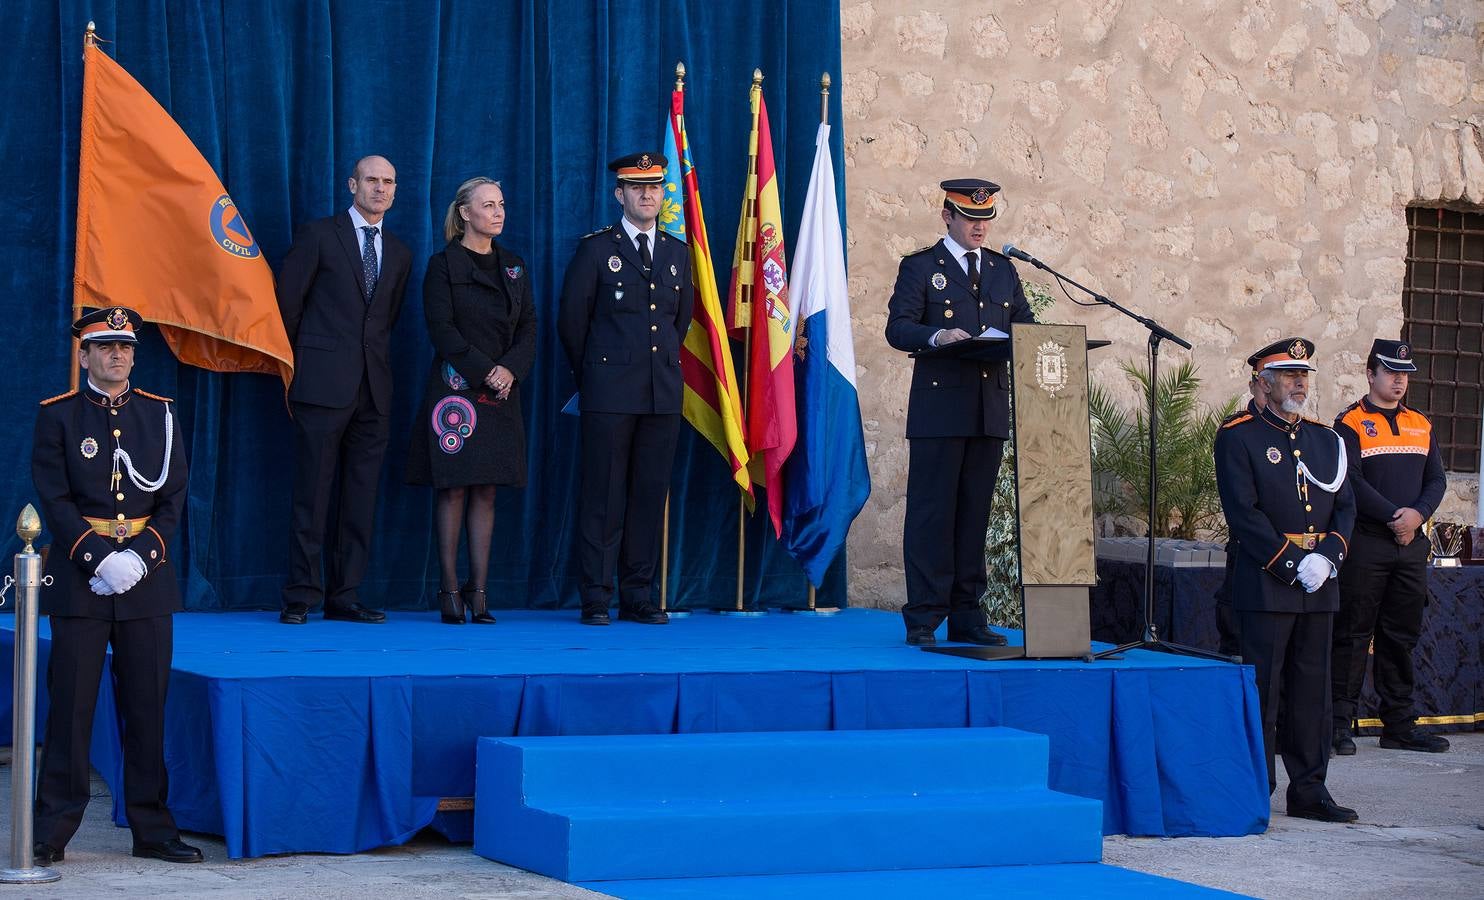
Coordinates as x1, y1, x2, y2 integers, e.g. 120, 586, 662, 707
276, 156, 413, 625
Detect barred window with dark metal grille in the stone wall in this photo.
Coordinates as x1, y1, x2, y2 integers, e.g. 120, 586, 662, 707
1401, 206, 1484, 472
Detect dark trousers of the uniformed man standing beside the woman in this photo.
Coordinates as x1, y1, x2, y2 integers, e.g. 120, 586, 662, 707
577, 411, 680, 609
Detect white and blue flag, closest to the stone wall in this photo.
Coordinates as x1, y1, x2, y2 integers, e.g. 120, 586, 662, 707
784, 125, 871, 587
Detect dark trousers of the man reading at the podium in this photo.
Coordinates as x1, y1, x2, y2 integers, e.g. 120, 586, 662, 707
902, 438, 1005, 631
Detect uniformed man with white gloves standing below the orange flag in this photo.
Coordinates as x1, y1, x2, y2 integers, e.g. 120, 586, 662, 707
31, 306, 202, 866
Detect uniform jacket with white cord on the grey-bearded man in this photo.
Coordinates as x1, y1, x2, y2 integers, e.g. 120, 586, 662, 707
1215, 408, 1355, 612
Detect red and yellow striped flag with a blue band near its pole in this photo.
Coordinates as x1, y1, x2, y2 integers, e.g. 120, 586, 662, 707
659, 75, 752, 496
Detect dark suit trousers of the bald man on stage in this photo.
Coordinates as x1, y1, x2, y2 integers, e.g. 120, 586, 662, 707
283, 379, 390, 609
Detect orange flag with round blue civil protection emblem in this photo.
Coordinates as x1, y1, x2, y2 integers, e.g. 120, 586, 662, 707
73, 40, 294, 389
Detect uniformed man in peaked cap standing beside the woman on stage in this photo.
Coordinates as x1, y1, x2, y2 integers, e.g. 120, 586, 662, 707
557, 153, 692, 625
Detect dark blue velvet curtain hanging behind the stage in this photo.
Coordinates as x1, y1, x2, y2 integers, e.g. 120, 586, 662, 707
0, 0, 844, 609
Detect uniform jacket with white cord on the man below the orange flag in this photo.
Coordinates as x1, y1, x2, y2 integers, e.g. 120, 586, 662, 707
31, 386, 187, 619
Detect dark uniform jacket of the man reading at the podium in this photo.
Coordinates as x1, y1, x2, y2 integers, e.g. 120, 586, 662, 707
886, 241, 1036, 438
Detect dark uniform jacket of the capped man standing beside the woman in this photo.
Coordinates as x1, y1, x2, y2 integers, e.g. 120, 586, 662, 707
557, 223, 695, 414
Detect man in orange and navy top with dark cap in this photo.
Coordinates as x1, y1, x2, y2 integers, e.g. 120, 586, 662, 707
1333, 340, 1448, 756
